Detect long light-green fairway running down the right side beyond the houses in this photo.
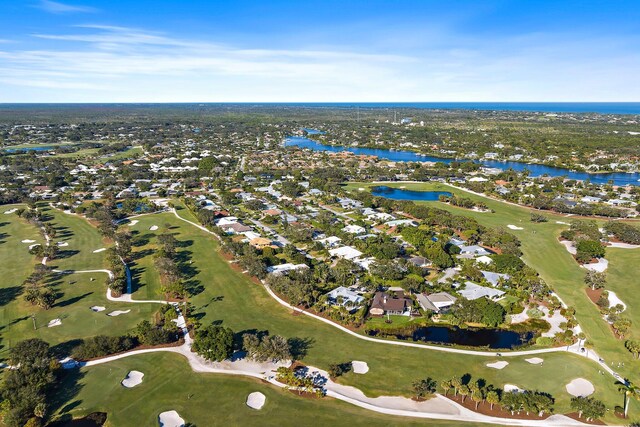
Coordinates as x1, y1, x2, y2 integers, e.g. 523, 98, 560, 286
347, 183, 640, 380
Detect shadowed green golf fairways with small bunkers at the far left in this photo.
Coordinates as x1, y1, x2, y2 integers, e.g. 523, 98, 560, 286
0, 206, 152, 357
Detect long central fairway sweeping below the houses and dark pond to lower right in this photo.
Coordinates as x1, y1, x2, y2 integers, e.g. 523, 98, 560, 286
162, 207, 632, 422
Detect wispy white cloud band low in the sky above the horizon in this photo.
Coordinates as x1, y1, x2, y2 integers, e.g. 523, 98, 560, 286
0, 25, 640, 102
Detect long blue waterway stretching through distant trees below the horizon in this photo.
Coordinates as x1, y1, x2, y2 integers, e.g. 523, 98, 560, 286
284, 136, 640, 186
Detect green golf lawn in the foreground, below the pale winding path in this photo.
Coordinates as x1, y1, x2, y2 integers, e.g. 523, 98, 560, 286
55, 353, 480, 427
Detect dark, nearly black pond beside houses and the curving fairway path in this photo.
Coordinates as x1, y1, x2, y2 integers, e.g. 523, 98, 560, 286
413, 326, 534, 349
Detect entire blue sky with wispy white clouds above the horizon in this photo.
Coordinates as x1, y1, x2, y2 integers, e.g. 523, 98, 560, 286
0, 0, 640, 102
